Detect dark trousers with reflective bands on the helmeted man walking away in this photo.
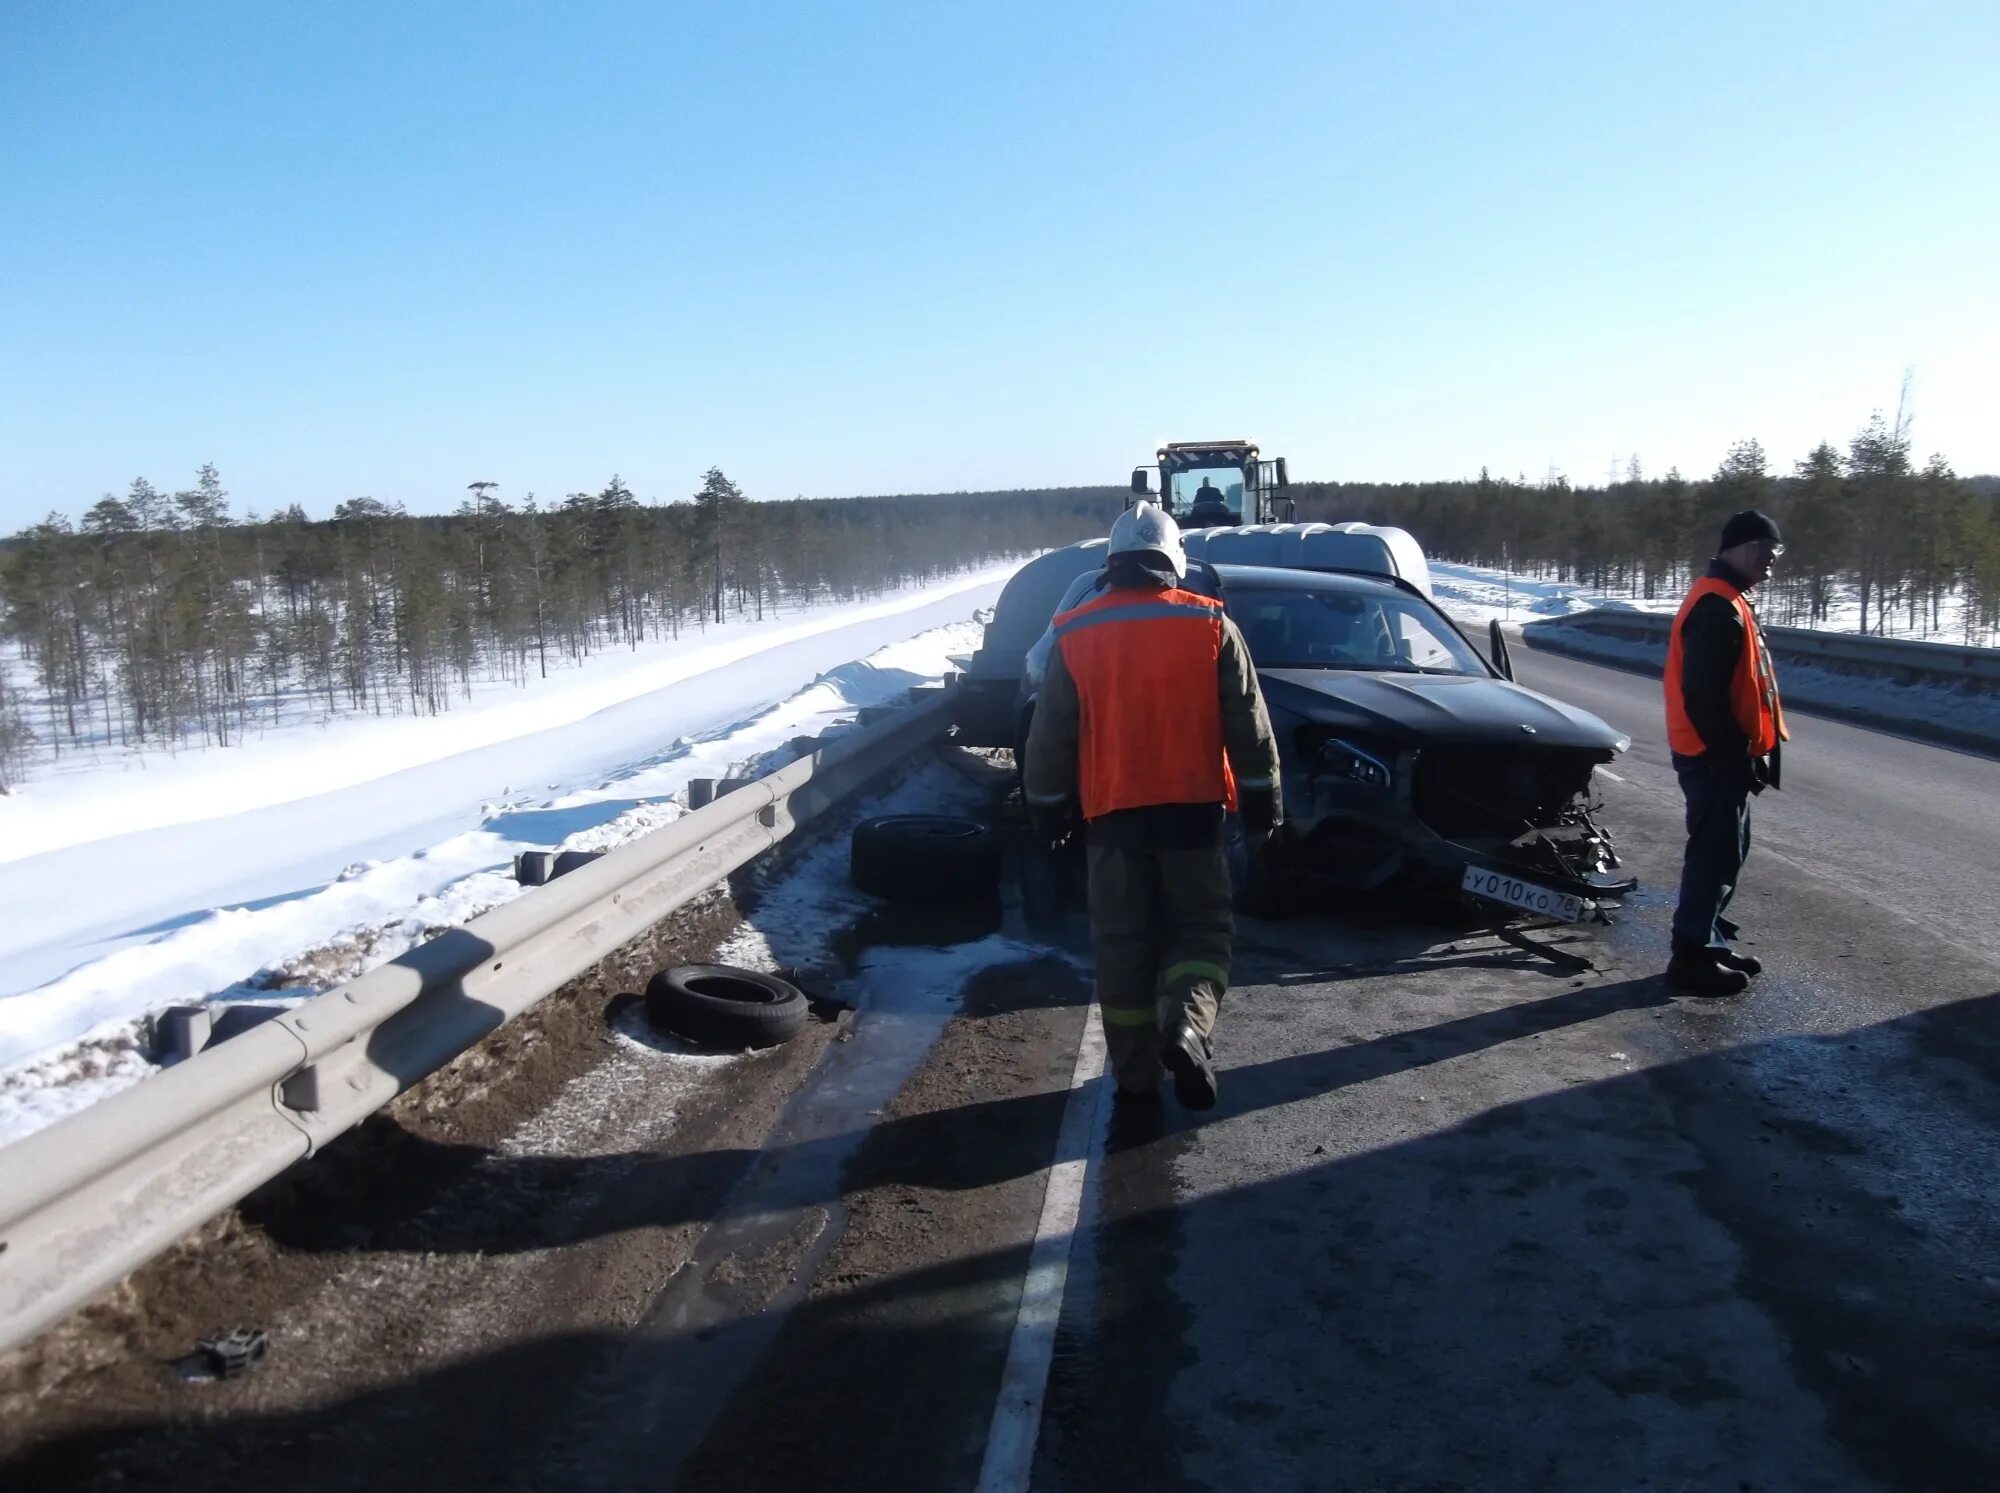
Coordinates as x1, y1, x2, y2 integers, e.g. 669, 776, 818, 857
1088, 805, 1236, 1095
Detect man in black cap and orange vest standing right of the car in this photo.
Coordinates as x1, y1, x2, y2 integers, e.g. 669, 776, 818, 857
1666, 508, 1790, 995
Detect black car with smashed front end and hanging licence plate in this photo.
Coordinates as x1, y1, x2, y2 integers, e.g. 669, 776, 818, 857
1216, 564, 1632, 923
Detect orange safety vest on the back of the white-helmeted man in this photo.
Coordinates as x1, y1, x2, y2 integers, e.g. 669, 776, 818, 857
1054, 588, 1236, 819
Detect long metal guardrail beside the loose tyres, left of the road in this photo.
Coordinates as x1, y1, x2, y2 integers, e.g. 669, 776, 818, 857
0, 690, 952, 1351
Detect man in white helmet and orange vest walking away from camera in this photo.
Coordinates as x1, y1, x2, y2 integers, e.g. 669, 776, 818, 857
1024, 502, 1282, 1109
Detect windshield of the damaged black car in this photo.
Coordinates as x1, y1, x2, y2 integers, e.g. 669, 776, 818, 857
1228, 586, 1486, 674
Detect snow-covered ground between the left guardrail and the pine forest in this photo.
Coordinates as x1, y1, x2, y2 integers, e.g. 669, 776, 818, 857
0, 564, 1014, 1145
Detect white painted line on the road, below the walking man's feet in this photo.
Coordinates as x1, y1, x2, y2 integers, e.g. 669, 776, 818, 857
978, 1001, 1110, 1493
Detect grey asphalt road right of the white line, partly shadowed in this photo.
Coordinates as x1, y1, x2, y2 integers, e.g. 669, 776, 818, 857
1016, 654, 2000, 1489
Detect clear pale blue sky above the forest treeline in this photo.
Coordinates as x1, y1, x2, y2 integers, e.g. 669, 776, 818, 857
0, 0, 2000, 530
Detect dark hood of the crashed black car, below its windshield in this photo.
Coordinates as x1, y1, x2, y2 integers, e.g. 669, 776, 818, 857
1258, 668, 1632, 753
